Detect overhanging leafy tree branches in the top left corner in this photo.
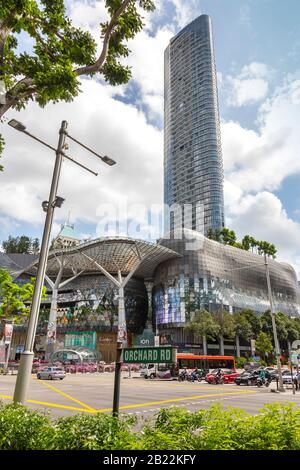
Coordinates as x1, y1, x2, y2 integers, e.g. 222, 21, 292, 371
0, 0, 155, 169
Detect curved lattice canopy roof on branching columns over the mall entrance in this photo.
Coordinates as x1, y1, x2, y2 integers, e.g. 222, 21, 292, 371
26, 236, 181, 278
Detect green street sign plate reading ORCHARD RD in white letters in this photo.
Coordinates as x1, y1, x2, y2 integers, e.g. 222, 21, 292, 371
123, 346, 177, 364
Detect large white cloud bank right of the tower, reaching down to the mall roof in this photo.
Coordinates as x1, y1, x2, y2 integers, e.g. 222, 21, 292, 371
221, 77, 300, 273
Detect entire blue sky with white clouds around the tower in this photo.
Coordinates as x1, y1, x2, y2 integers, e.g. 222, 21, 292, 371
0, 0, 300, 276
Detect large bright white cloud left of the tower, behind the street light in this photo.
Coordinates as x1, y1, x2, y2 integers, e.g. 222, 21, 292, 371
0, 80, 163, 237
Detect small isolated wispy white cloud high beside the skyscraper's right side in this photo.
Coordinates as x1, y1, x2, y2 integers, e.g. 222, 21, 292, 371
225, 62, 272, 107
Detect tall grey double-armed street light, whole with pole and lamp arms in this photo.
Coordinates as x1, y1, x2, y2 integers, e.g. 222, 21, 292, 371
8, 119, 116, 404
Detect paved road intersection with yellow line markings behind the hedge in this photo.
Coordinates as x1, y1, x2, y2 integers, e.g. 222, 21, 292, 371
0, 373, 300, 418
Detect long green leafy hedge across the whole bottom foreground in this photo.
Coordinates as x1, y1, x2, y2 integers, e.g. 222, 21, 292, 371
0, 403, 300, 450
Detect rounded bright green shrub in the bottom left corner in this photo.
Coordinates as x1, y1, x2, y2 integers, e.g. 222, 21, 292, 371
0, 403, 55, 450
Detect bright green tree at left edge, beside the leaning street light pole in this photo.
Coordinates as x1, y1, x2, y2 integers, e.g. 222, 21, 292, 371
0, 269, 46, 323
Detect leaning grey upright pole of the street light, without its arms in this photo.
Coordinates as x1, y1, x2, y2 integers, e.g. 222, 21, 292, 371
13, 121, 67, 404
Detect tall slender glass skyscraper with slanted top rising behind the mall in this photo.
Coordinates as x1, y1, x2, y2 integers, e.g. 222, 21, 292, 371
164, 15, 224, 234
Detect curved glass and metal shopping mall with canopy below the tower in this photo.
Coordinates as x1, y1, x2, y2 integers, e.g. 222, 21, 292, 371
0, 230, 300, 362
